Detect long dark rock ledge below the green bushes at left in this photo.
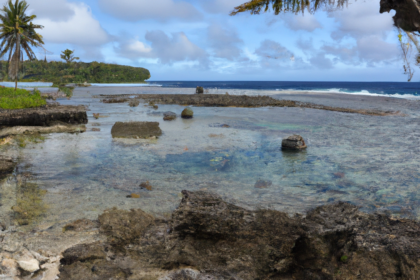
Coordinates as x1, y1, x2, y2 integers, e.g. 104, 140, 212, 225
0, 105, 88, 127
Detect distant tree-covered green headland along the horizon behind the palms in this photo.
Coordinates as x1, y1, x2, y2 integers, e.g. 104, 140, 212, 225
0, 60, 150, 85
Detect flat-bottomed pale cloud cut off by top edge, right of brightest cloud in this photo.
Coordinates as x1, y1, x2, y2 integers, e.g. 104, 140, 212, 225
98, 0, 201, 21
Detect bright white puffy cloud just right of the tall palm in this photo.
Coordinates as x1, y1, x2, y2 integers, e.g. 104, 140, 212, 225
36, 3, 110, 46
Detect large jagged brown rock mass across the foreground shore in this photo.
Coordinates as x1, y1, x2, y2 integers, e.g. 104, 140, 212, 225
60, 191, 420, 280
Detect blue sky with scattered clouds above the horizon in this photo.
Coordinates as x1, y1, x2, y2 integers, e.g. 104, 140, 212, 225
23, 0, 410, 81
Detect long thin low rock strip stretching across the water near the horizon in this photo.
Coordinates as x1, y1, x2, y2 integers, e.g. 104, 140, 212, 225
97, 94, 403, 116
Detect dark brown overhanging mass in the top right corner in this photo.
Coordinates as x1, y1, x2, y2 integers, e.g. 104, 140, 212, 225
380, 0, 420, 32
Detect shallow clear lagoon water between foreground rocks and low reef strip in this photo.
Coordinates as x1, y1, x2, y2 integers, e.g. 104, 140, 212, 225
2, 88, 420, 231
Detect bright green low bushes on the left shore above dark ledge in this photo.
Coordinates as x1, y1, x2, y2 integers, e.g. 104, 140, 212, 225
0, 88, 47, 109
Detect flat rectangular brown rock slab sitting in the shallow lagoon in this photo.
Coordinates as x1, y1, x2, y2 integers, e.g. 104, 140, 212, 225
111, 122, 162, 139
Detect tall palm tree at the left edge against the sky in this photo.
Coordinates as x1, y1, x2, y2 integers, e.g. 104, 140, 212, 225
0, 0, 44, 90
